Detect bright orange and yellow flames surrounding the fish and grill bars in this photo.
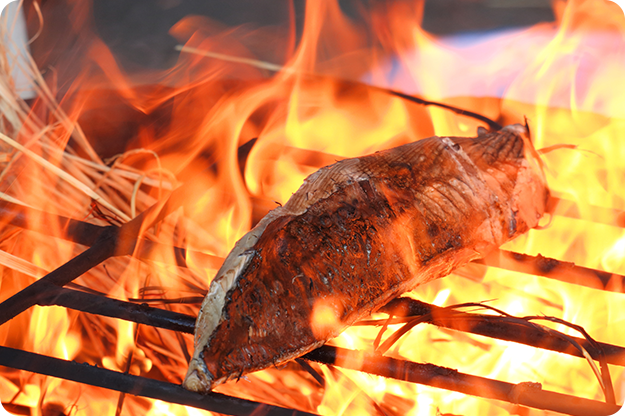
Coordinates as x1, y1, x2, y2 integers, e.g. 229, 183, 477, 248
0, 0, 625, 416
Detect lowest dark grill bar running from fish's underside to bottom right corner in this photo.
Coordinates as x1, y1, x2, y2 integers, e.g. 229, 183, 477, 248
303, 345, 625, 416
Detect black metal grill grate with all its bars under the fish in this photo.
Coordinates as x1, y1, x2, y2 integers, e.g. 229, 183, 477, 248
0, 197, 625, 416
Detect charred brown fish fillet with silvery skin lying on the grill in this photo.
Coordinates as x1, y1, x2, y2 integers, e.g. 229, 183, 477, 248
183, 125, 549, 392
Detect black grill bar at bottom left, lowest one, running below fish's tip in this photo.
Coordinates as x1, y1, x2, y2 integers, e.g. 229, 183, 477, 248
0, 346, 313, 416
